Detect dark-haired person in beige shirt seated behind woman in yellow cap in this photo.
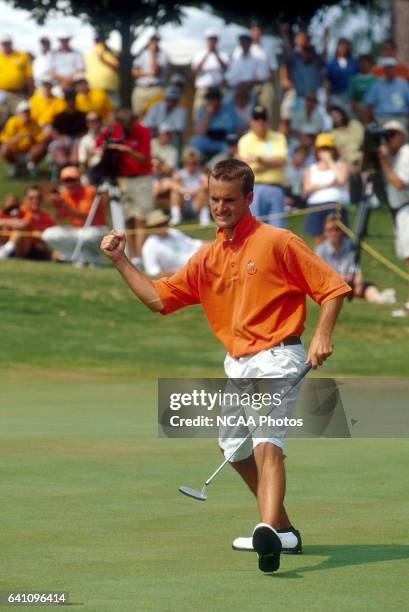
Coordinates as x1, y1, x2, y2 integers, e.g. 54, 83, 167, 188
329, 105, 364, 168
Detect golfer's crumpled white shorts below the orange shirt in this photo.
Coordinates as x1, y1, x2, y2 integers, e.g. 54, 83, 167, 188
219, 344, 306, 462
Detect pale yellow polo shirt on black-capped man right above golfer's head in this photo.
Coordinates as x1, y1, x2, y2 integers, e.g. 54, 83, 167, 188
238, 130, 287, 185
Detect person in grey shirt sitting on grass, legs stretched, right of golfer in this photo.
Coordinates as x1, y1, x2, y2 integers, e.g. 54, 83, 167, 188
315, 215, 396, 304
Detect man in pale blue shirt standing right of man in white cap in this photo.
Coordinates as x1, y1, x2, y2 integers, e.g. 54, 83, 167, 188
225, 33, 269, 94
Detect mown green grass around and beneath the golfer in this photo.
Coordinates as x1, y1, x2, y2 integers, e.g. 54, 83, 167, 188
0, 204, 409, 612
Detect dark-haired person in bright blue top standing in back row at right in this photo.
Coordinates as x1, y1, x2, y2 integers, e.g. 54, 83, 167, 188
326, 38, 358, 106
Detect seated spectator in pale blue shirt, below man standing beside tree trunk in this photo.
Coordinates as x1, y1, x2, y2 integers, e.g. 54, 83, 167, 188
143, 87, 187, 149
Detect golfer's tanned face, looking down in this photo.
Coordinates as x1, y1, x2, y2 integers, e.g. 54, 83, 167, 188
209, 178, 253, 231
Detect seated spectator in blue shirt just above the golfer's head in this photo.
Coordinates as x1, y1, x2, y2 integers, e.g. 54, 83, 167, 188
189, 88, 242, 158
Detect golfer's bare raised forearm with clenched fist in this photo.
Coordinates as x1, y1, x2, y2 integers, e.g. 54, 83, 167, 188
101, 230, 163, 312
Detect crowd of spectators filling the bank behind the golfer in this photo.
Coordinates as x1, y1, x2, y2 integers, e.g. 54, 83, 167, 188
0, 22, 409, 310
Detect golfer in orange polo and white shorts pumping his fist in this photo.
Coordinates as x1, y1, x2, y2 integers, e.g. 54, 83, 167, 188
101, 159, 351, 572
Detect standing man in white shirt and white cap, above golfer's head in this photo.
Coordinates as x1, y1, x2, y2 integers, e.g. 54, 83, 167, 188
192, 29, 229, 116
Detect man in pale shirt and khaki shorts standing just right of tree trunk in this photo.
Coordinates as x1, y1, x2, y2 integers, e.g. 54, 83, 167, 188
132, 34, 168, 116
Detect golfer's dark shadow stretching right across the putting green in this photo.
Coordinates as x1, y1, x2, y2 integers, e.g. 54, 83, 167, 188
271, 544, 409, 578
